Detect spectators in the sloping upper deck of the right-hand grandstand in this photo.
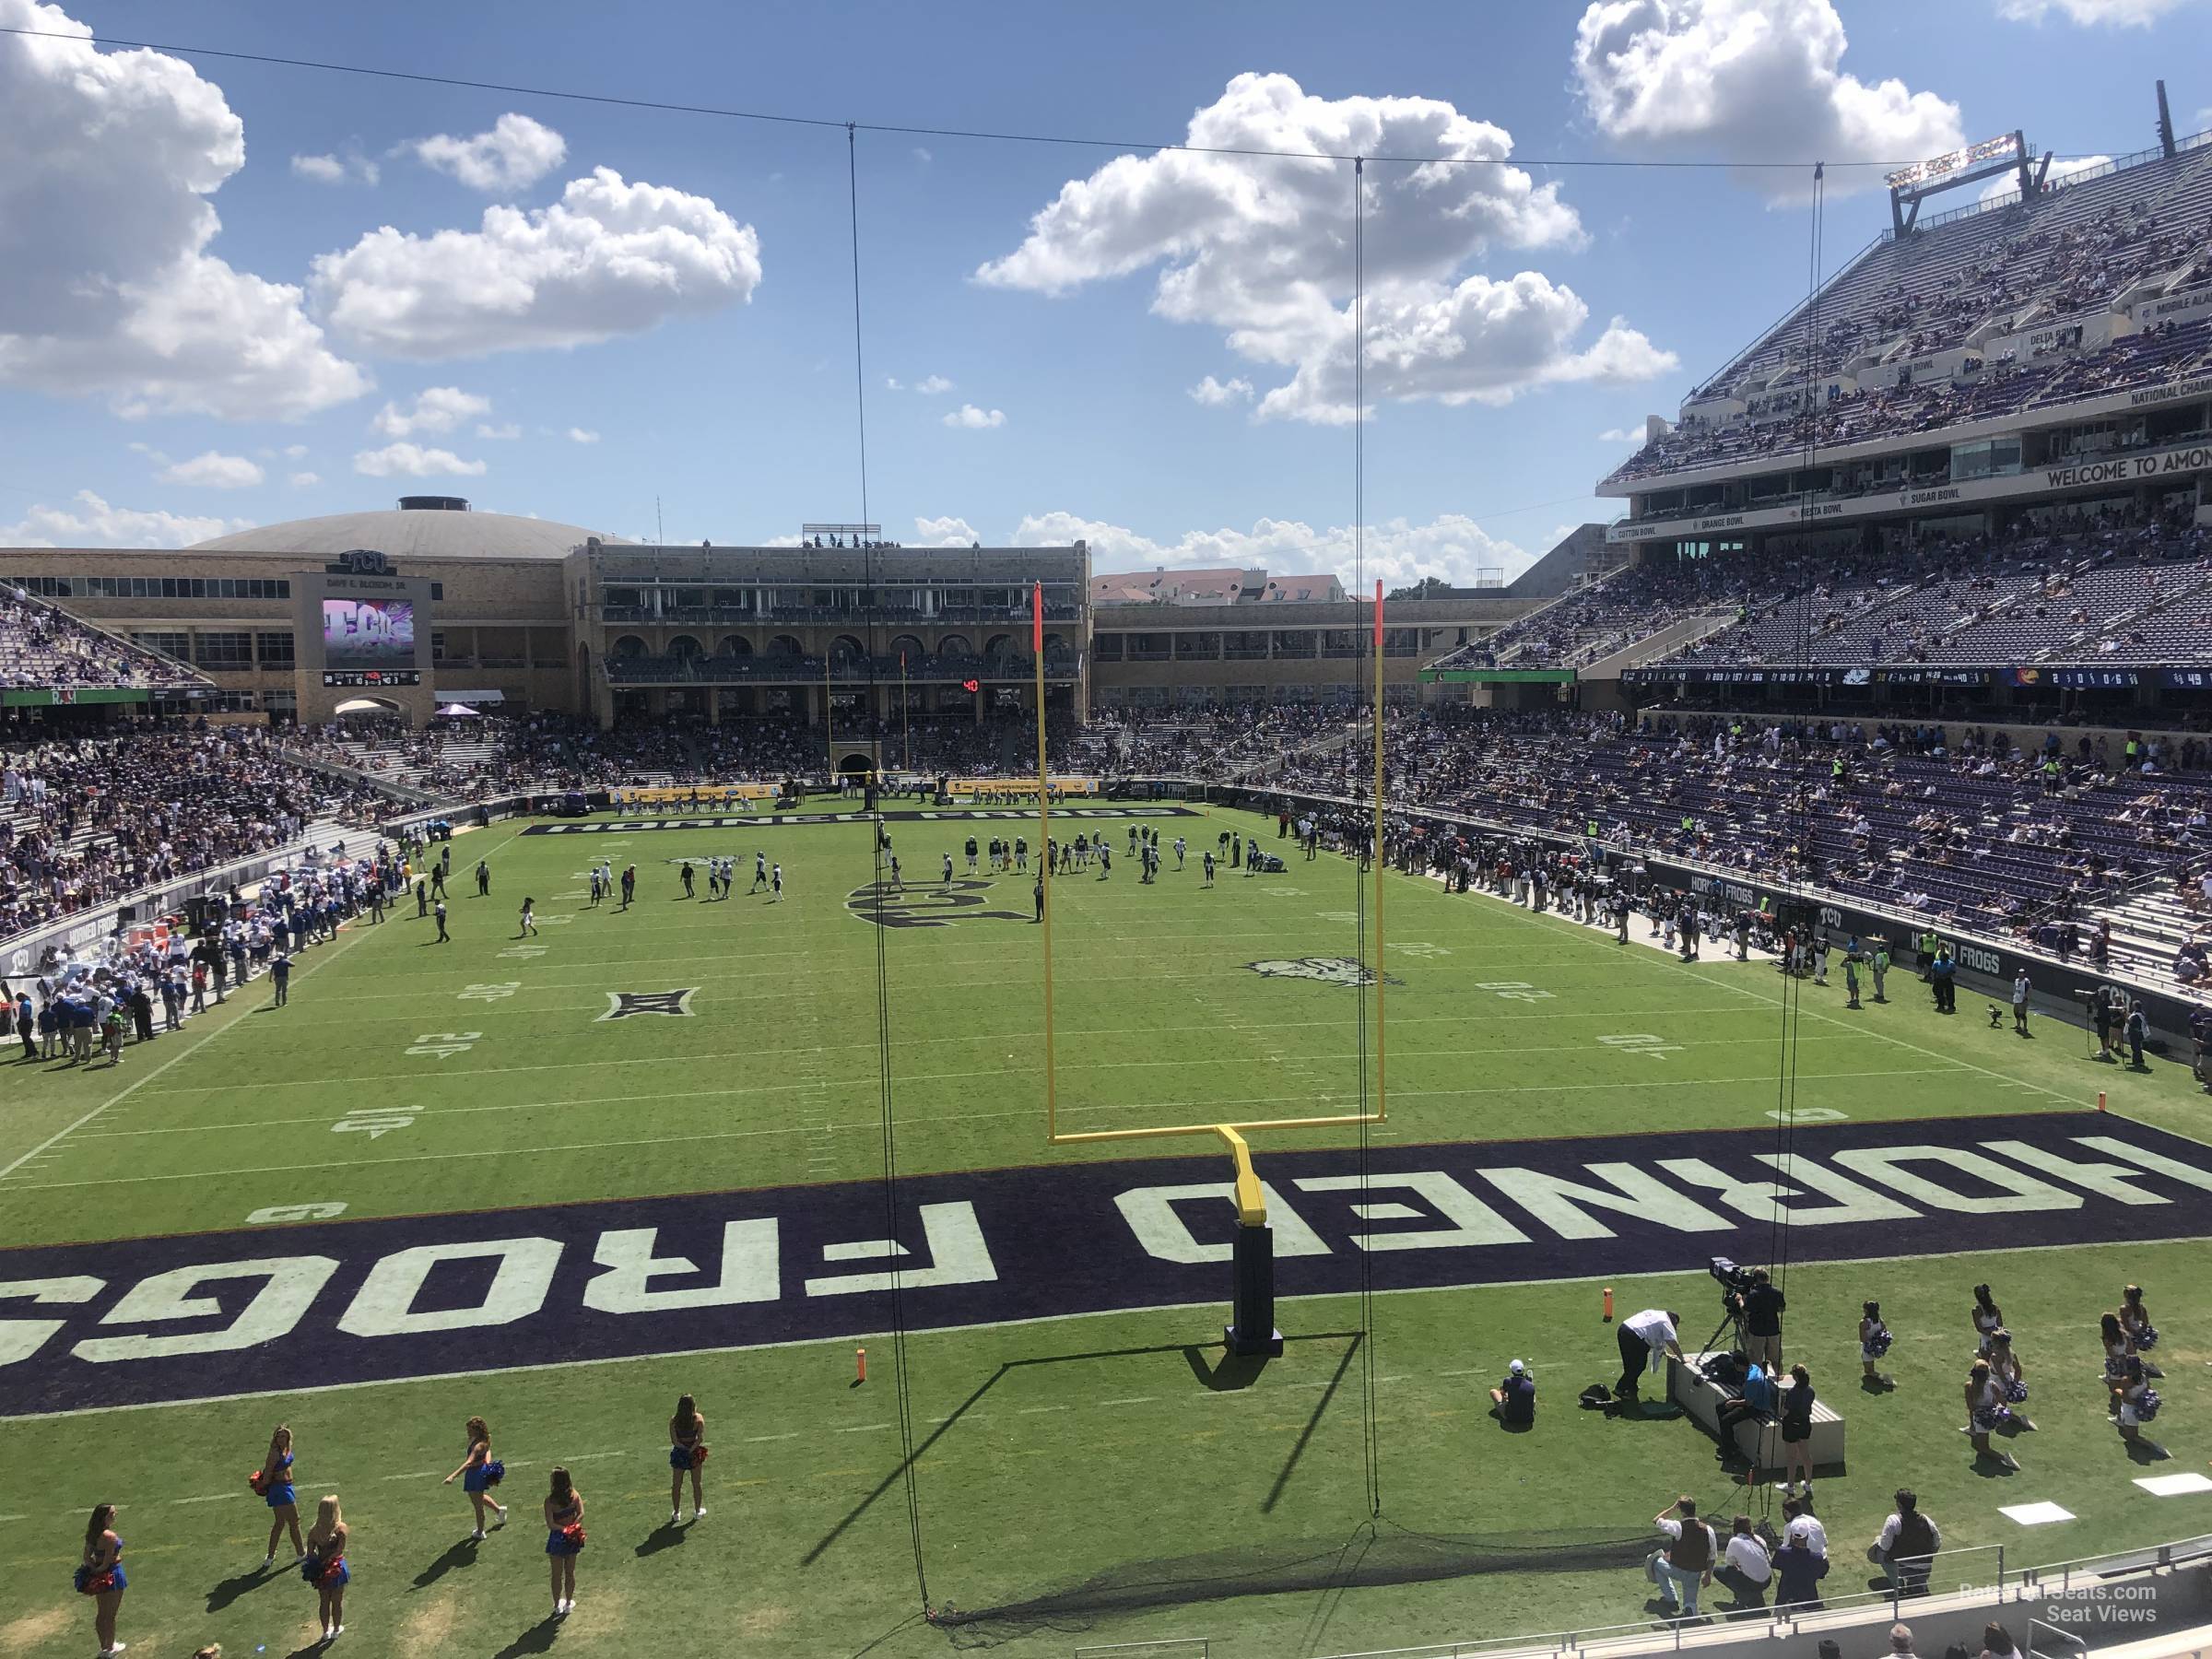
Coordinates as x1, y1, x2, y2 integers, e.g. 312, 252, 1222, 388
1613, 139, 2212, 482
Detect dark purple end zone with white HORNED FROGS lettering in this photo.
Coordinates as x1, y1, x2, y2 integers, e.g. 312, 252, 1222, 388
0, 1112, 2212, 1416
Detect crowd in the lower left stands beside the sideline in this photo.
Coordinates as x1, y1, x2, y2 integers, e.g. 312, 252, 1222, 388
0, 728, 378, 938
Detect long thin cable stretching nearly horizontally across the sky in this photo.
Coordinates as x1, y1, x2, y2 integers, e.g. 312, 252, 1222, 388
0, 27, 1991, 172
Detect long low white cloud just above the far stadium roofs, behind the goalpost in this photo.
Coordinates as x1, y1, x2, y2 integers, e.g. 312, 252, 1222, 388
1013, 513, 1533, 588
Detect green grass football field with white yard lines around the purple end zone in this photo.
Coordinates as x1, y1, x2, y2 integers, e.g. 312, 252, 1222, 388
0, 809, 2212, 1657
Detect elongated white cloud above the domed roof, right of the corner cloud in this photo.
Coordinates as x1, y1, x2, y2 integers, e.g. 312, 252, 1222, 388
307, 166, 761, 360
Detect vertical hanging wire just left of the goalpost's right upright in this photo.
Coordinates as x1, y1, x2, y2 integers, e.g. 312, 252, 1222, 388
1351, 157, 1382, 1520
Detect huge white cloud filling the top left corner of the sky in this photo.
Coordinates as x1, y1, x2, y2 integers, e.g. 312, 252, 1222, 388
0, 0, 370, 420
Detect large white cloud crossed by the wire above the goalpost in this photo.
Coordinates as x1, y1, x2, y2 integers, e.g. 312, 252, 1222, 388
975, 76, 1672, 422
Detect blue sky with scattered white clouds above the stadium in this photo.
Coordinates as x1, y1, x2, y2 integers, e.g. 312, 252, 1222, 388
0, 0, 2212, 580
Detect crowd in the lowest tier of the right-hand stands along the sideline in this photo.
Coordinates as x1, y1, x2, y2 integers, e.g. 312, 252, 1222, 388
1267, 710, 2212, 949
